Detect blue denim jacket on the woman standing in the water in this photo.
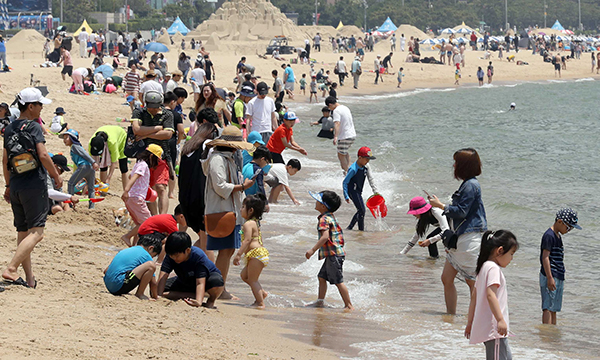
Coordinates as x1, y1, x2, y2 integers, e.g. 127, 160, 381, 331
444, 177, 487, 236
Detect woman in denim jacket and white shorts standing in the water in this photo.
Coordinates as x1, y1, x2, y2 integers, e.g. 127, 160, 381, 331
429, 148, 487, 314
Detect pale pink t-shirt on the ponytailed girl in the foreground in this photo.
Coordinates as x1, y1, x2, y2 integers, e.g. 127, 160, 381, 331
469, 261, 510, 344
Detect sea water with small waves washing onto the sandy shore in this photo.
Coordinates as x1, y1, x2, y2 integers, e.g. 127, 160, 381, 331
227, 79, 600, 359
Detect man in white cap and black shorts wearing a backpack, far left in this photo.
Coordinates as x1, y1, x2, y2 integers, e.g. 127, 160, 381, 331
2, 88, 62, 288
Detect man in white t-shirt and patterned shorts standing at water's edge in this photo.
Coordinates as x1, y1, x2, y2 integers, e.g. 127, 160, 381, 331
325, 96, 356, 175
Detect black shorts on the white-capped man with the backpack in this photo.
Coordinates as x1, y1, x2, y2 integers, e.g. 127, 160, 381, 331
10, 187, 49, 231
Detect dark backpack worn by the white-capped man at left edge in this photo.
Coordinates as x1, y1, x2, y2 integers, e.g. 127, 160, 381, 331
4, 120, 40, 174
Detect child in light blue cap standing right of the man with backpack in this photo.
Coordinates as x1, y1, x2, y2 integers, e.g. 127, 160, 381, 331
58, 129, 100, 209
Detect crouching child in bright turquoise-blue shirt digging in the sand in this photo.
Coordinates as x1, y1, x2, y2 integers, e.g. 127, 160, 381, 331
104, 234, 165, 300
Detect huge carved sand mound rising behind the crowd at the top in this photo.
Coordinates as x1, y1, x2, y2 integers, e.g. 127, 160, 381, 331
196, 0, 305, 41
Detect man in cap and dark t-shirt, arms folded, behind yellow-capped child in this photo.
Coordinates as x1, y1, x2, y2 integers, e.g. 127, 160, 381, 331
131, 90, 177, 215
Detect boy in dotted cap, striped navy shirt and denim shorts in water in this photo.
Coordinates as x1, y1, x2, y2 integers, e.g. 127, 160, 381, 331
540, 208, 581, 325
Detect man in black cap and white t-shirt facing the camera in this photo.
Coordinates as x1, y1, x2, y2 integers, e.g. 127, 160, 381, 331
246, 81, 277, 144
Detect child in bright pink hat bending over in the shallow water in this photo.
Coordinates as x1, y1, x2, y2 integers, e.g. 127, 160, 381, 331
400, 196, 450, 258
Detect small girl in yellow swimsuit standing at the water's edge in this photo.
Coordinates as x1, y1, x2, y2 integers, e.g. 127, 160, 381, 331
233, 194, 269, 309
